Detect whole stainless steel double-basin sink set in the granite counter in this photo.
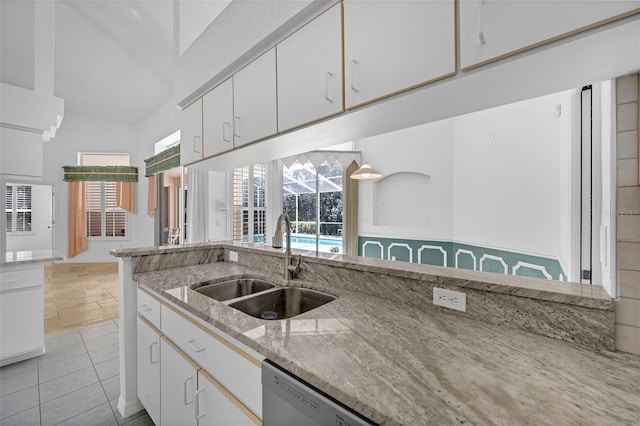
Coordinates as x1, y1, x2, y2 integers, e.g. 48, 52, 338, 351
191, 278, 336, 320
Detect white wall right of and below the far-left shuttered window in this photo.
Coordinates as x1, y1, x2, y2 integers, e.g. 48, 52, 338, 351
7, 185, 51, 251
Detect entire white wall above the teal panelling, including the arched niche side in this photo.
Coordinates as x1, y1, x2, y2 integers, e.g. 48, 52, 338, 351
358, 92, 573, 270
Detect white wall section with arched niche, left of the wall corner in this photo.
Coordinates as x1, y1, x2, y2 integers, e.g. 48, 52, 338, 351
356, 120, 453, 240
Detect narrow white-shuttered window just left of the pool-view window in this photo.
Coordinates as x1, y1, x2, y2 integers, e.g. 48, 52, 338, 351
232, 164, 267, 244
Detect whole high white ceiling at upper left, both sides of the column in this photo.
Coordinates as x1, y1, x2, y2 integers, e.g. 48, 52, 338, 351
1, 0, 229, 124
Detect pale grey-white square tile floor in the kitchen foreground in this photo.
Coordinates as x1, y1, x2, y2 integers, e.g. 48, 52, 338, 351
0, 319, 153, 426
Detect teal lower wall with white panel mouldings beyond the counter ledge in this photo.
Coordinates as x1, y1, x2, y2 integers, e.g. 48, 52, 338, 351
358, 236, 567, 281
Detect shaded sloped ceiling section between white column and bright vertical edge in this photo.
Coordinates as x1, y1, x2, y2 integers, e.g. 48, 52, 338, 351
54, 0, 176, 124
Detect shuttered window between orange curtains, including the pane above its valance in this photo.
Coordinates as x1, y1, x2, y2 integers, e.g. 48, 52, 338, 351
79, 153, 129, 238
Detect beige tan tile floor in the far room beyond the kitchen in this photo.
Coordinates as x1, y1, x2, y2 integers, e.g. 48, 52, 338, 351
44, 262, 118, 336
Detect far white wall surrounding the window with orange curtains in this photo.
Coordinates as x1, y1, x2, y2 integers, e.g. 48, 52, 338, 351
43, 112, 144, 262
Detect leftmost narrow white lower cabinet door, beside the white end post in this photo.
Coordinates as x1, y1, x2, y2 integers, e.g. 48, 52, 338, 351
138, 318, 160, 425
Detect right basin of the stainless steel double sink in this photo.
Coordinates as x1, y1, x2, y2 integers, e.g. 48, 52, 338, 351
229, 287, 336, 319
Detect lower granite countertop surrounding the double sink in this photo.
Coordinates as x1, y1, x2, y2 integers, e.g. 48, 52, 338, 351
134, 262, 640, 425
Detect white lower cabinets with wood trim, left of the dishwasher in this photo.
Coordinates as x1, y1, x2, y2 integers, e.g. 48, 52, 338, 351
137, 300, 264, 426
